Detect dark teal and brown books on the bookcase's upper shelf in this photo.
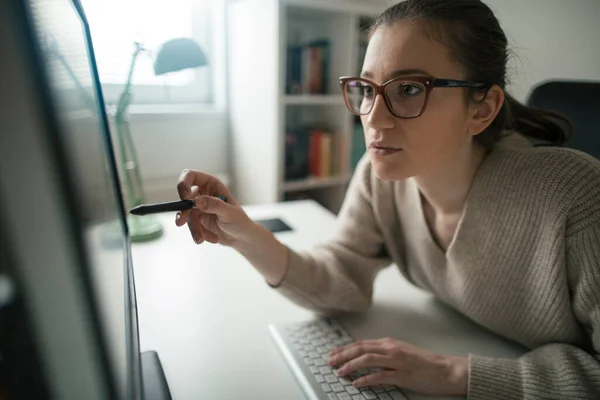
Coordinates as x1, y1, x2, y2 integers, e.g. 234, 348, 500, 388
286, 39, 330, 94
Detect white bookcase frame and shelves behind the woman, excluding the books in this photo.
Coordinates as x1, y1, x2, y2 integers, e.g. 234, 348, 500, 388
227, 0, 392, 212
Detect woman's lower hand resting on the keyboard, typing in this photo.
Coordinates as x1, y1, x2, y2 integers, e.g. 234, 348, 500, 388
329, 338, 469, 396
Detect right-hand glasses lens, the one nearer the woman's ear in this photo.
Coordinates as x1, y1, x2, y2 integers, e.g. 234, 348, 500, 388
385, 81, 427, 118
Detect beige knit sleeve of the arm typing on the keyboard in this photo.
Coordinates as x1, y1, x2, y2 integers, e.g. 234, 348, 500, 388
468, 219, 600, 400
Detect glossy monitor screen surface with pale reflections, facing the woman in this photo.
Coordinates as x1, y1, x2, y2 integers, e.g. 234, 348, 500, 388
29, 0, 139, 399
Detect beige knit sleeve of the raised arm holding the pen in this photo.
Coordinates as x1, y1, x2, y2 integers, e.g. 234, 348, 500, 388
270, 157, 391, 314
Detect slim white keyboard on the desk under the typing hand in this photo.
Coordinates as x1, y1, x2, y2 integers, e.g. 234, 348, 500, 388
269, 318, 408, 400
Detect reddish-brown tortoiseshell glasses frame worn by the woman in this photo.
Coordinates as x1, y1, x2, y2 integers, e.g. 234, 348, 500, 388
340, 76, 491, 119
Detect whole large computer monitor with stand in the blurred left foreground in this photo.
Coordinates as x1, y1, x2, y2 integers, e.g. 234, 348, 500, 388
0, 0, 170, 400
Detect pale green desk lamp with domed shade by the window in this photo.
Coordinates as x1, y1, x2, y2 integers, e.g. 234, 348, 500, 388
115, 38, 207, 242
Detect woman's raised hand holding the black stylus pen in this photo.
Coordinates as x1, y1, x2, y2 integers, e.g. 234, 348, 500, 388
175, 170, 254, 246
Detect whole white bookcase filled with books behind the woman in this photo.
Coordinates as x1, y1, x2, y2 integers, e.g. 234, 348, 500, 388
227, 0, 387, 213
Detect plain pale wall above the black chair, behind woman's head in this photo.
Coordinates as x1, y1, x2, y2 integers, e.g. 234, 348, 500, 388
484, 0, 600, 101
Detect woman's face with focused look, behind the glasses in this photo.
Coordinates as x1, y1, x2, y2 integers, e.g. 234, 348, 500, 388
361, 22, 472, 180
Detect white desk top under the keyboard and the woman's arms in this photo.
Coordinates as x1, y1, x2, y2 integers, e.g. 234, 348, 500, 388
133, 201, 524, 400
